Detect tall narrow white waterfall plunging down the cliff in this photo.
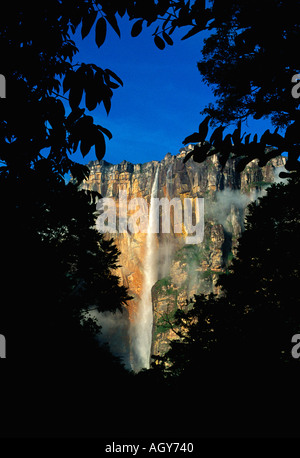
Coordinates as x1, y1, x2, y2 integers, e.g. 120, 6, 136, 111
134, 164, 159, 370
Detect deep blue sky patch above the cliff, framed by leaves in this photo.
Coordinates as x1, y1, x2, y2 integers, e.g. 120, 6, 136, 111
72, 17, 269, 164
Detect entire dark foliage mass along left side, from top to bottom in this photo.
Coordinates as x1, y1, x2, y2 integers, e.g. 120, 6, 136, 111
0, 1, 137, 436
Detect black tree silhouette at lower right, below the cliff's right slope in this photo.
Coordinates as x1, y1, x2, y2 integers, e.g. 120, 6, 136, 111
148, 180, 300, 436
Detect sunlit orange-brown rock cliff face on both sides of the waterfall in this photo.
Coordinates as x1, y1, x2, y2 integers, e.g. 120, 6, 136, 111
83, 147, 285, 367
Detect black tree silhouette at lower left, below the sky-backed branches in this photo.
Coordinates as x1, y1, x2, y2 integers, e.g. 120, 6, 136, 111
0, 160, 135, 436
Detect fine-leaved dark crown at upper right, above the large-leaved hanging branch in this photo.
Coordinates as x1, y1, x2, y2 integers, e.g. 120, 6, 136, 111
198, 0, 300, 127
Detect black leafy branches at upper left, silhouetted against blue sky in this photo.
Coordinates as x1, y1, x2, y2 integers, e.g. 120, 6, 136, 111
0, 0, 123, 182
